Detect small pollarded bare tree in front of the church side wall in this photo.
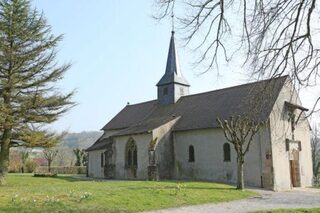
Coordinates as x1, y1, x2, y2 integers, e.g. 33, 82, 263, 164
217, 115, 263, 190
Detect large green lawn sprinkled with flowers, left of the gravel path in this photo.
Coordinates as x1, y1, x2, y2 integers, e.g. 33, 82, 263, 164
0, 174, 255, 213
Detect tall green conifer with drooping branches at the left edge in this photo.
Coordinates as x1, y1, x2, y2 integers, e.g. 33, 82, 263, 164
0, 0, 74, 182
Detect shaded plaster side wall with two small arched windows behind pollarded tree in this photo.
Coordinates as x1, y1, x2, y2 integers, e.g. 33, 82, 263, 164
174, 128, 270, 186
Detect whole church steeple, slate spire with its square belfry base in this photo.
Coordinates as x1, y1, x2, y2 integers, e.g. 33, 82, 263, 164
157, 30, 190, 104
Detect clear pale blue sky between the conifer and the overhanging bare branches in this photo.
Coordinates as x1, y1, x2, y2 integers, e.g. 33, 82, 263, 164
32, 0, 318, 132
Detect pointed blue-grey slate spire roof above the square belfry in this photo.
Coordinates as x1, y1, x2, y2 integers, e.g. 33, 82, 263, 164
157, 31, 189, 86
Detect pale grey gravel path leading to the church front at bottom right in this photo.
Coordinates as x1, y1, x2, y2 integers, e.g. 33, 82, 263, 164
146, 188, 320, 213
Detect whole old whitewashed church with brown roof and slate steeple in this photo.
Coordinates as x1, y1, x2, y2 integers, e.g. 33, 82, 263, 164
87, 32, 312, 191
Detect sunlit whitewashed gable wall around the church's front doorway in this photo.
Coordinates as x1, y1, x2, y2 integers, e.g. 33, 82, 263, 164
270, 83, 312, 190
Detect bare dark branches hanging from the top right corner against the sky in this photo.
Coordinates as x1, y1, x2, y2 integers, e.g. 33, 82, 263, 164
155, 0, 320, 113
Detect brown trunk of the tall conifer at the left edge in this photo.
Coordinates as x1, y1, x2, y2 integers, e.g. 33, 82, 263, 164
0, 129, 11, 185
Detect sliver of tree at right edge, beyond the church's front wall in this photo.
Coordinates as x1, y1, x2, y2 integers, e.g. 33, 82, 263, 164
311, 127, 320, 184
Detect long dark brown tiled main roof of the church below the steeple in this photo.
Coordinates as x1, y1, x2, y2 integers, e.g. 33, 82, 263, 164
102, 76, 288, 135
